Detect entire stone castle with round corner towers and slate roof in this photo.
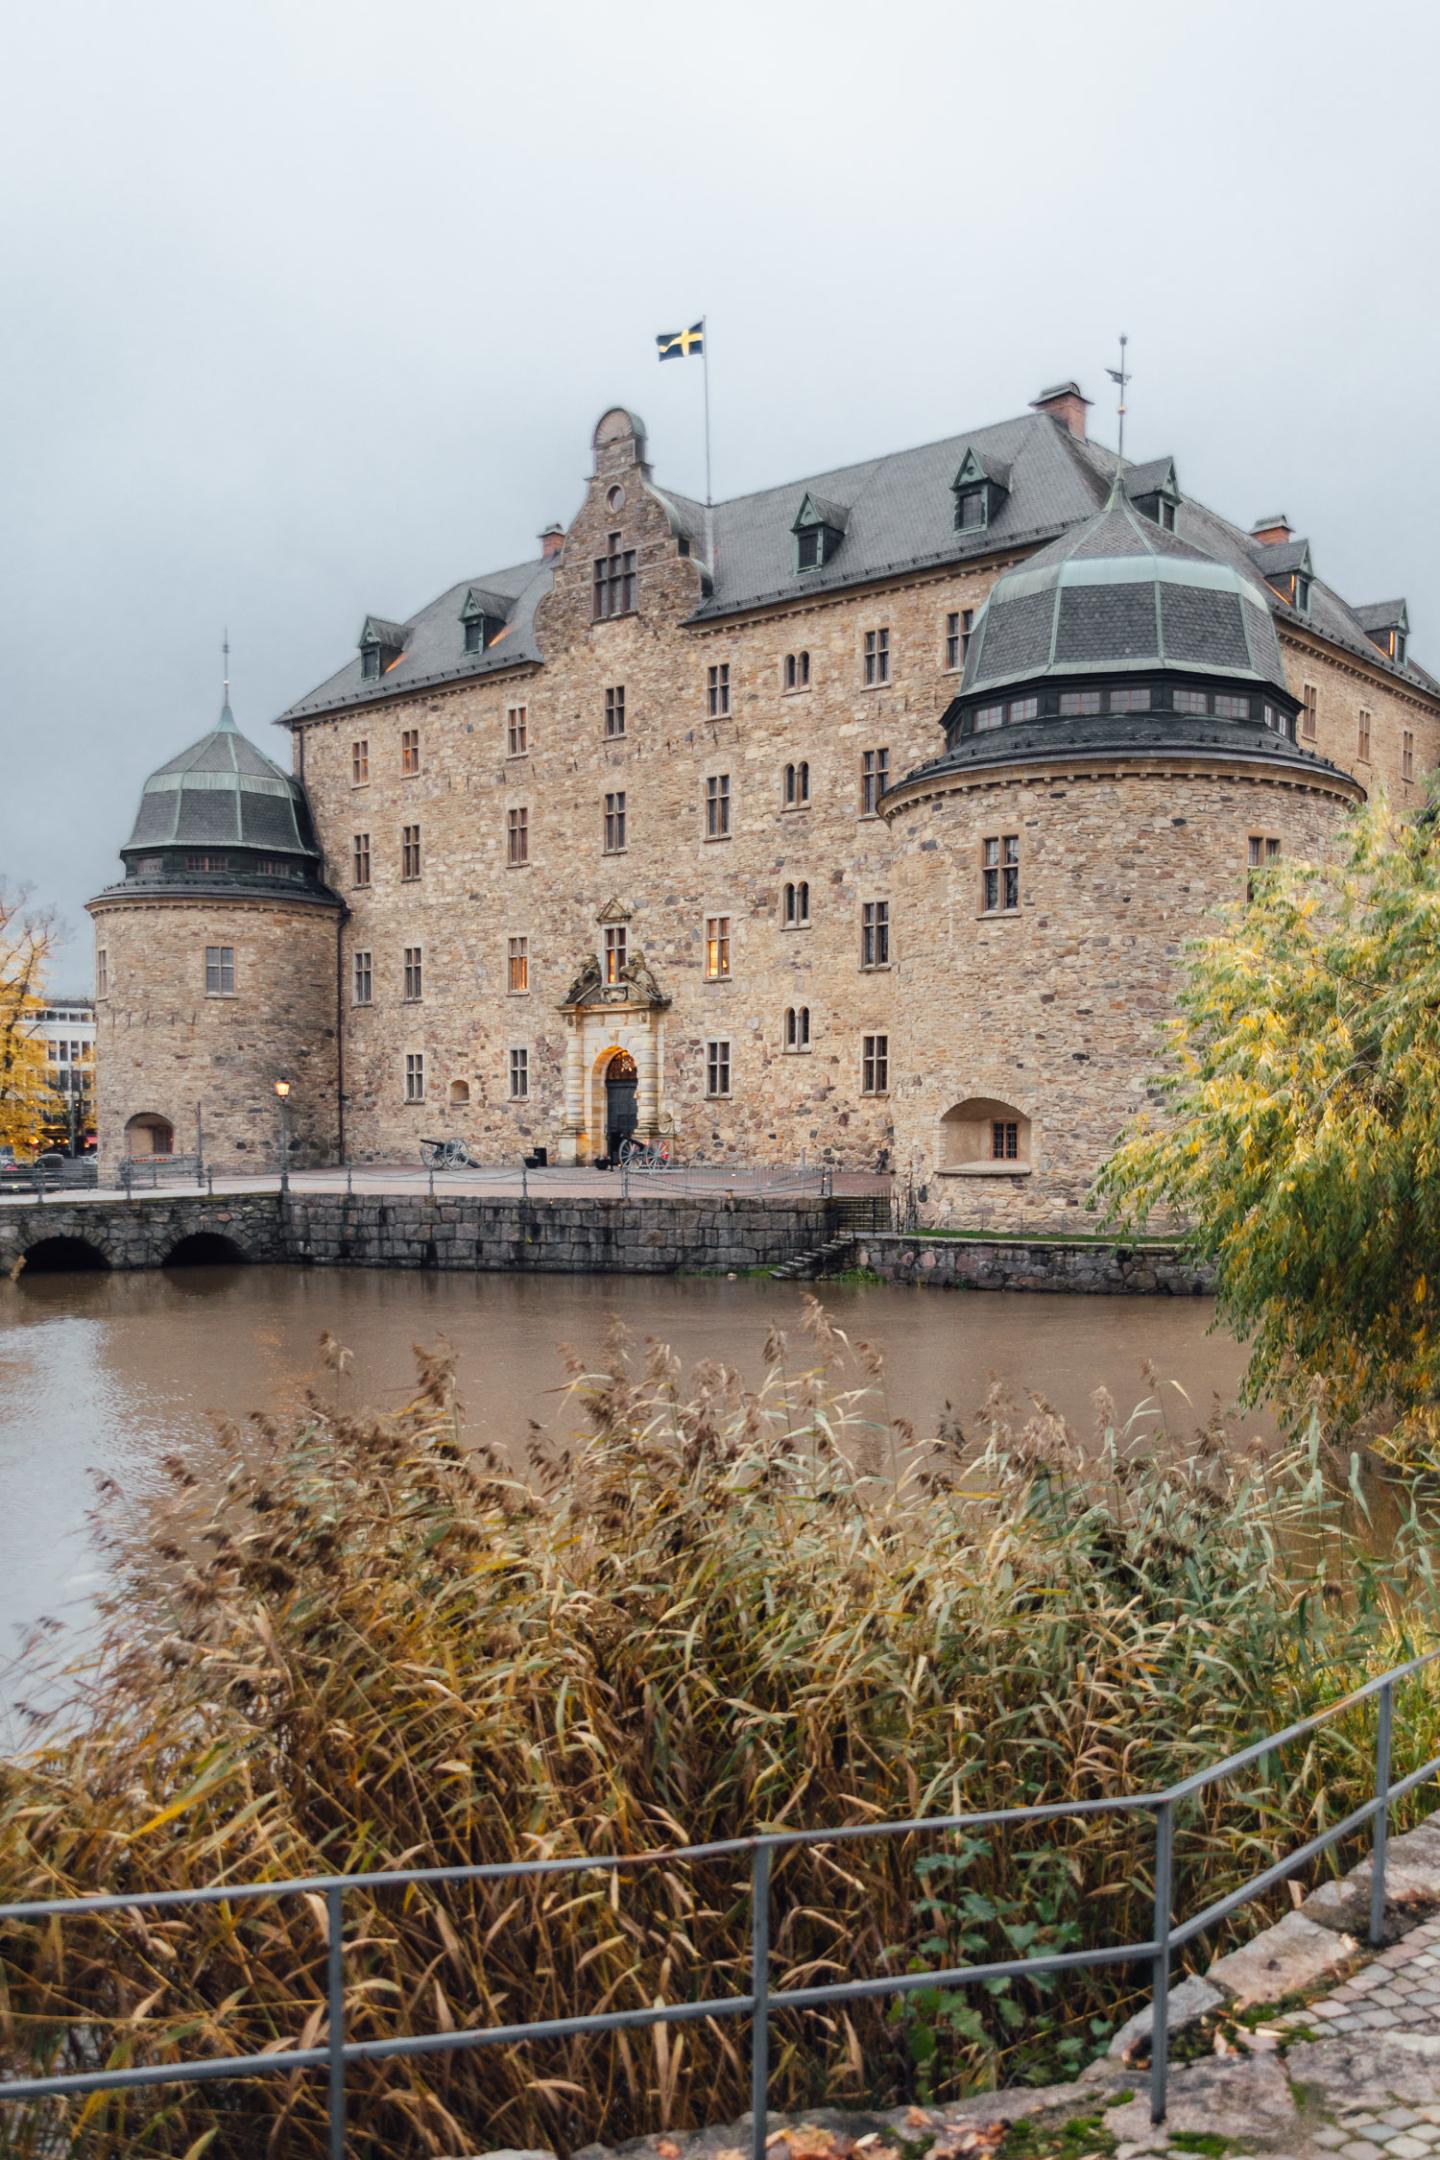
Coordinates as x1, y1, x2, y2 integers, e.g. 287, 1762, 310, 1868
91, 382, 1440, 1229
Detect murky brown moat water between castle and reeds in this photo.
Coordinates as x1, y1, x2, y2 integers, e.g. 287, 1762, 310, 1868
0, 1268, 1259, 1704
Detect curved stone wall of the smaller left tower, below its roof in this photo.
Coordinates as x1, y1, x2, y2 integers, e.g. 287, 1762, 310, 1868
93, 894, 339, 1171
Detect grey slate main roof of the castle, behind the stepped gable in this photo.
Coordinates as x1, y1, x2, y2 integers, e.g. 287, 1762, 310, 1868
281, 408, 1436, 721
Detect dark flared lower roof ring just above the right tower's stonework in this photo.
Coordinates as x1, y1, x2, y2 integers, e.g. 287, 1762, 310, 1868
892, 713, 1364, 795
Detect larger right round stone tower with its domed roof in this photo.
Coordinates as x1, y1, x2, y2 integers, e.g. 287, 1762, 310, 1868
883, 488, 1364, 1231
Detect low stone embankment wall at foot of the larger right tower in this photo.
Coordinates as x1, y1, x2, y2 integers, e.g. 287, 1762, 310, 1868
853, 1231, 1215, 1298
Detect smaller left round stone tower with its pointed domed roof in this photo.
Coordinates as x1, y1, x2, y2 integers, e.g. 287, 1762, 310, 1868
89, 700, 343, 1171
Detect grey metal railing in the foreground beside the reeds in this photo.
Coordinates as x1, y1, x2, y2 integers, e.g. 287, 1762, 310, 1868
0, 1650, 1440, 2160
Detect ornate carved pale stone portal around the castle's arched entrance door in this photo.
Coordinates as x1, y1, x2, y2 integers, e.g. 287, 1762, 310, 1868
559, 901, 669, 1162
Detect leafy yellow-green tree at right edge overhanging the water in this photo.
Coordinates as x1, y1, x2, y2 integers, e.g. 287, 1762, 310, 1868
1097, 799, 1440, 1456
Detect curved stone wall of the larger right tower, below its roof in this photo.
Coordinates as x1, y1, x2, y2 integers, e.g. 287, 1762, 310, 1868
892, 756, 1347, 1231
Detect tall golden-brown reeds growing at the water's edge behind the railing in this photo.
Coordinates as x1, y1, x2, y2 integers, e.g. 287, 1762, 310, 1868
0, 1307, 1440, 2160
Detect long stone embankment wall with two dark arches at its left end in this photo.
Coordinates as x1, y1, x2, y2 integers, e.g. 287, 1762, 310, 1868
0, 1192, 829, 1274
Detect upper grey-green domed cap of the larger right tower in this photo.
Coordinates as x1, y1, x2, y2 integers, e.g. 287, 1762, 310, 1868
961, 486, 1285, 698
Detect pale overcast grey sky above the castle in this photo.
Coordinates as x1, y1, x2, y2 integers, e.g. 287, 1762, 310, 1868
0, 0, 1440, 989
